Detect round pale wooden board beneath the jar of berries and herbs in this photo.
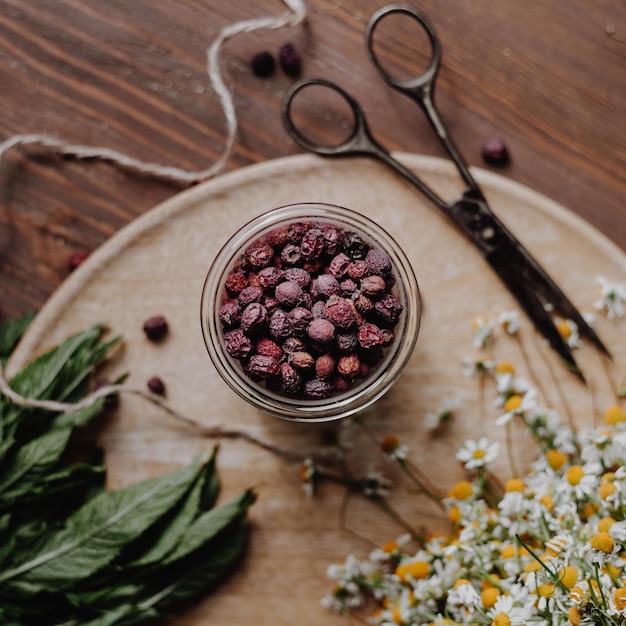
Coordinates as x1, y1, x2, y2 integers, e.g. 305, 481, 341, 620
10, 154, 626, 626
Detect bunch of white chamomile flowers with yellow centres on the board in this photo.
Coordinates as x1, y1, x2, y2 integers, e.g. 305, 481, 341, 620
322, 279, 626, 626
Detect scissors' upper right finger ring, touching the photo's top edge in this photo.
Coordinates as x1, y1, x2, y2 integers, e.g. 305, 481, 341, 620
365, 4, 441, 91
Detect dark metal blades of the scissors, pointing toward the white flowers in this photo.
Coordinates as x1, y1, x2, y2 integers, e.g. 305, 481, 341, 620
447, 192, 610, 370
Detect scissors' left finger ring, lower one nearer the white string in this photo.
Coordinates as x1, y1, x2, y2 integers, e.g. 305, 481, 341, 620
281, 78, 371, 156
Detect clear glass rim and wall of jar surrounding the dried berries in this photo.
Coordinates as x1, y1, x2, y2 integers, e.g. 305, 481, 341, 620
201, 203, 421, 422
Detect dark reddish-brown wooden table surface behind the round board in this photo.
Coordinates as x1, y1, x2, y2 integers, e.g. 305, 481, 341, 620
0, 0, 626, 317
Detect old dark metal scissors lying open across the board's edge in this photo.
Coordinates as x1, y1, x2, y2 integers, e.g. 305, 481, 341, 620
282, 4, 610, 380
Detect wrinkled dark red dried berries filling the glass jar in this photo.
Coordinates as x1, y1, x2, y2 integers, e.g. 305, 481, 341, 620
218, 221, 404, 399
